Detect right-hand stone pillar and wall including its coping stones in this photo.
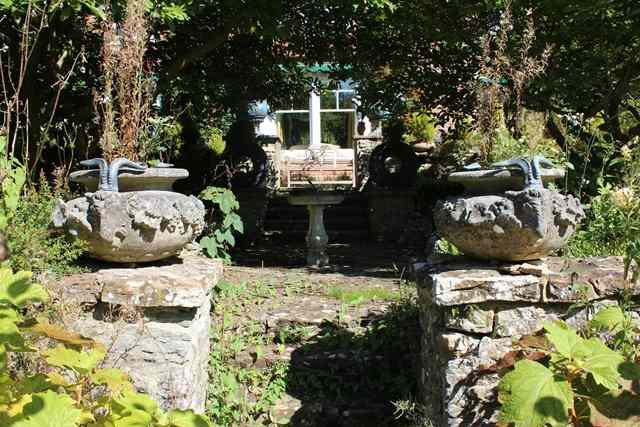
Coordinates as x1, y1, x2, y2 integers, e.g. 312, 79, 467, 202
417, 257, 640, 427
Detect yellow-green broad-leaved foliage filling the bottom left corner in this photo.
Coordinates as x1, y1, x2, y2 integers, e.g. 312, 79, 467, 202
0, 268, 211, 427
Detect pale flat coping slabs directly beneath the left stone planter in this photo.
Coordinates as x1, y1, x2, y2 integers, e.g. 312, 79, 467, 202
47, 257, 223, 308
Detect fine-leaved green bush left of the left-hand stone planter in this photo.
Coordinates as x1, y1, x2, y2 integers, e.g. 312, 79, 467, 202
7, 180, 85, 274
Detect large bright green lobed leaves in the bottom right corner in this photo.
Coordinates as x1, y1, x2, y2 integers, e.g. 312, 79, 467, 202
498, 307, 640, 427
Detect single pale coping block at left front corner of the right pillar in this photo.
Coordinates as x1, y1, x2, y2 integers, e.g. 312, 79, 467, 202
426, 268, 542, 306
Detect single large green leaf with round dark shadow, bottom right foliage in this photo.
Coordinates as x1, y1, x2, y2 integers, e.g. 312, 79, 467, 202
498, 360, 573, 427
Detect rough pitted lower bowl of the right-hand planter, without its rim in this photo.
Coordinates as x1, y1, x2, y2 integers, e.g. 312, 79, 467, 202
434, 188, 584, 261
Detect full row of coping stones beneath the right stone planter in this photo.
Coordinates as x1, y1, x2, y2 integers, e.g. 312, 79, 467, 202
416, 257, 640, 306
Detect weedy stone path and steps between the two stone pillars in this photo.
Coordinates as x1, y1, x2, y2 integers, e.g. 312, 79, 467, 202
213, 240, 420, 426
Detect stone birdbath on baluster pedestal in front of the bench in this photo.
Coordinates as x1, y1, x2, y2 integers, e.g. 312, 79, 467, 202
288, 191, 344, 267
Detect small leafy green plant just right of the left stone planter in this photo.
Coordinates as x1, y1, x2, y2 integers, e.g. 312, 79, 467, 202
199, 187, 244, 261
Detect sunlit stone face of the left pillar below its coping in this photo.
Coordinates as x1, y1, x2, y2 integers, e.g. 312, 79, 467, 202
70, 299, 211, 412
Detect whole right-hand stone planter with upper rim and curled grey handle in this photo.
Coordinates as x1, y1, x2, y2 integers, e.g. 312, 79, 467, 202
434, 159, 584, 261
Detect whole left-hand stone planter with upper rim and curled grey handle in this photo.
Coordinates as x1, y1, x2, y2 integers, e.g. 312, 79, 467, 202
53, 158, 205, 263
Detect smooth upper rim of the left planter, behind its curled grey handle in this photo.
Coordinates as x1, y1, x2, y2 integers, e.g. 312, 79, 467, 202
69, 167, 189, 192
